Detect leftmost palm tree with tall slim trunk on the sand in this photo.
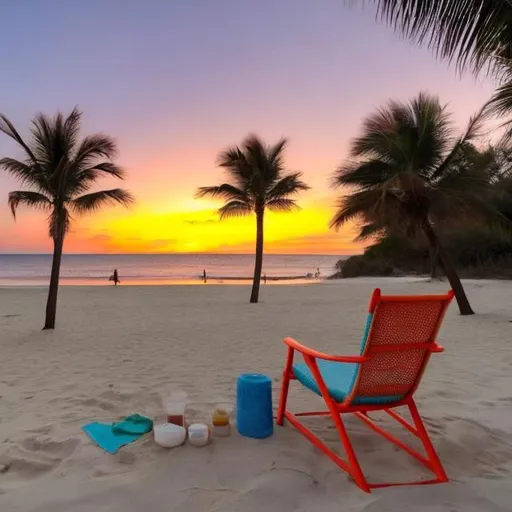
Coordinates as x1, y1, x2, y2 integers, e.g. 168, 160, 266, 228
0, 108, 133, 329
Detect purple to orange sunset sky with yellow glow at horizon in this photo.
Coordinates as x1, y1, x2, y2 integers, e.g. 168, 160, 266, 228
0, 0, 494, 254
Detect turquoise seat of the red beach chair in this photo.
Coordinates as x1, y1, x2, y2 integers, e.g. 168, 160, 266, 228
293, 360, 403, 405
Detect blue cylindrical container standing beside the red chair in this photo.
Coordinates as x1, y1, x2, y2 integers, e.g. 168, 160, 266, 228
236, 373, 274, 439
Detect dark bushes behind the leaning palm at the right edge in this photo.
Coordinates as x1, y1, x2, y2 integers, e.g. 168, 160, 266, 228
332, 140, 512, 279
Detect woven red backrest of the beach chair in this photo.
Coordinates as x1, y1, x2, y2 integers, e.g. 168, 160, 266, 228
351, 289, 453, 399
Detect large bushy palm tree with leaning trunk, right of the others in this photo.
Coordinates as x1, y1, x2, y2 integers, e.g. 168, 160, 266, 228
331, 93, 491, 315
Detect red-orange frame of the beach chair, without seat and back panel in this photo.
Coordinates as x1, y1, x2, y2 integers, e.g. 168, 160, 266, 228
277, 289, 454, 493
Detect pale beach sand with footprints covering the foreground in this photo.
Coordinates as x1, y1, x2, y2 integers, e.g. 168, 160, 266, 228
0, 279, 512, 512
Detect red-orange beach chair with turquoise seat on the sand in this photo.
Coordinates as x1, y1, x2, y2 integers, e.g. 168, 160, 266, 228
277, 289, 453, 492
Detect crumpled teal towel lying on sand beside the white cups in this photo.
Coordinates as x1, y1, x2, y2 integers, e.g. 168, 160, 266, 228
82, 414, 153, 453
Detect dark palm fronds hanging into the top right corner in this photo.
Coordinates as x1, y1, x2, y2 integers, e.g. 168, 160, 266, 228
374, 0, 512, 73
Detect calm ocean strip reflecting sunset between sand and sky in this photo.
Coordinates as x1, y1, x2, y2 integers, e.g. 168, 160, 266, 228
0, 254, 340, 286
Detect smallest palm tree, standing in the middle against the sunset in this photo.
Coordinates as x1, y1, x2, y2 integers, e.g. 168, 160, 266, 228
196, 135, 309, 302
